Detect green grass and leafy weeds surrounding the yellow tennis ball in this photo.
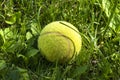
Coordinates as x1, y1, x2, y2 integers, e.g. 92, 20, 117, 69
0, 0, 120, 80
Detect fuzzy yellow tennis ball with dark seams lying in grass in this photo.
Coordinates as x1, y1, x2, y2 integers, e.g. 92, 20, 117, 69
38, 21, 82, 63
